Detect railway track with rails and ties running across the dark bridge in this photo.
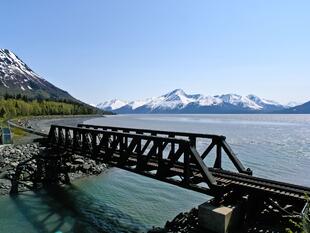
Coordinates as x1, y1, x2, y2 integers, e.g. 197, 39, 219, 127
59, 147, 310, 202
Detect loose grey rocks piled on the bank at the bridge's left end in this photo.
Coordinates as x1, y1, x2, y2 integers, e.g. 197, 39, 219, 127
0, 143, 106, 195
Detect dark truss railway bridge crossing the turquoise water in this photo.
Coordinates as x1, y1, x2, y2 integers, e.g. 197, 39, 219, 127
11, 124, 310, 220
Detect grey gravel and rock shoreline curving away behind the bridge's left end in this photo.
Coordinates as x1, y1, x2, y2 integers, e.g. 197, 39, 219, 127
0, 115, 108, 196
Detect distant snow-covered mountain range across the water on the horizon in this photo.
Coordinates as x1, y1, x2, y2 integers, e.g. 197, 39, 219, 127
97, 89, 286, 113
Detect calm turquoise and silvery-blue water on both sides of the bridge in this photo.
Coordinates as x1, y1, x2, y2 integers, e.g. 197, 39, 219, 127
0, 115, 310, 232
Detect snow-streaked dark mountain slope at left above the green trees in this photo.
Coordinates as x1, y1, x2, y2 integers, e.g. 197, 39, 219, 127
0, 49, 76, 101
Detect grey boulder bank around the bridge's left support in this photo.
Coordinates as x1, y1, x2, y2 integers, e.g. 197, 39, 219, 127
0, 143, 108, 196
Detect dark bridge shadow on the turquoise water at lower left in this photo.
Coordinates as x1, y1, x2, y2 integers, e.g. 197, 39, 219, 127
12, 184, 147, 233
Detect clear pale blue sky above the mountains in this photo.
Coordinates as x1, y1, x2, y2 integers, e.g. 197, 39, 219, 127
0, 0, 310, 103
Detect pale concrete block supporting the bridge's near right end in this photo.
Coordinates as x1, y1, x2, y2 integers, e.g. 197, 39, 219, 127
198, 200, 243, 233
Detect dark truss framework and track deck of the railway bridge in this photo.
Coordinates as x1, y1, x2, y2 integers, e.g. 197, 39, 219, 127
49, 124, 310, 206
